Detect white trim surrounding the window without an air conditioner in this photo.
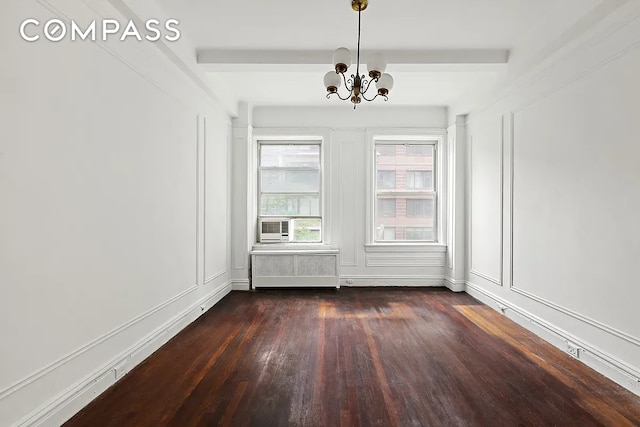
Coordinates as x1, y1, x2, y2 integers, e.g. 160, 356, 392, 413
365, 128, 447, 246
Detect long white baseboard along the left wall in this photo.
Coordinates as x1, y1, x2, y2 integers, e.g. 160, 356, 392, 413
15, 282, 231, 427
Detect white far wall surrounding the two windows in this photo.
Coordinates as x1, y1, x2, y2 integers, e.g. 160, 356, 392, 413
234, 103, 447, 286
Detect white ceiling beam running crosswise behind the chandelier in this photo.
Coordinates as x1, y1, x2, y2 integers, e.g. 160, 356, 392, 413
197, 49, 510, 71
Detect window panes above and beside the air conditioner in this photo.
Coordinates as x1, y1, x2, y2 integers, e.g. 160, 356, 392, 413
258, 141, 322, 242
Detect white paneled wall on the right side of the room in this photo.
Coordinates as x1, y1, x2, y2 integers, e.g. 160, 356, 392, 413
457, 2, 640, 393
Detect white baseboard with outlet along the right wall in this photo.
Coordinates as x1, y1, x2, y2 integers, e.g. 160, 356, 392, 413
466, 282, 640, 396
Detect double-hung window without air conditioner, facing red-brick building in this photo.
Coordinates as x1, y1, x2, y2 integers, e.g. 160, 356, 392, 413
374, 139, 437, 242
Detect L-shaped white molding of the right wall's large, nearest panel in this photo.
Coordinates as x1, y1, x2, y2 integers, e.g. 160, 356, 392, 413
509, 112, 640, 346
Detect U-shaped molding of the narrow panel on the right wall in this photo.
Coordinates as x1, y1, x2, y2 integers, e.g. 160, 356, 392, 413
468, 115, 505, 286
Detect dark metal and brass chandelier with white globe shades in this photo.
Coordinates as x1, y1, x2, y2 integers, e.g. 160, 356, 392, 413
324, 0, 393, 109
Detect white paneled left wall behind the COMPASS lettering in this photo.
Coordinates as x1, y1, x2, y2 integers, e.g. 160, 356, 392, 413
0, 0, 231, 426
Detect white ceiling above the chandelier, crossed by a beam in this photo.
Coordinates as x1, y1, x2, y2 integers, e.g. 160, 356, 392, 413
158, 0, 607, 106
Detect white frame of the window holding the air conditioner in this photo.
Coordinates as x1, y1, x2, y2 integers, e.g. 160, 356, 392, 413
254, 136, 327, 246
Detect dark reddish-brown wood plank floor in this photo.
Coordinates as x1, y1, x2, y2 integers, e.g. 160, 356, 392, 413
66, 288, 640, 427
